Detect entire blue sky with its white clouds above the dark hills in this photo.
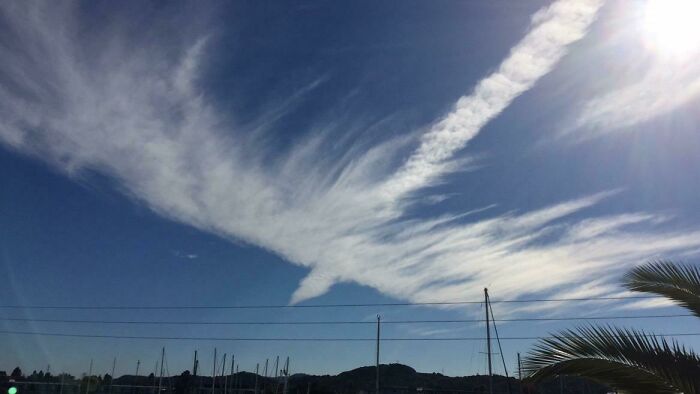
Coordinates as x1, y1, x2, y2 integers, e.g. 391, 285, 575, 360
0, 0, 700, 375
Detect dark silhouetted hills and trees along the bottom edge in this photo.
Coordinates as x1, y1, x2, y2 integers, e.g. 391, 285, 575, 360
0, 364, 608, 394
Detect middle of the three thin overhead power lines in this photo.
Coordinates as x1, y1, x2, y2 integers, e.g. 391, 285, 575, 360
0, 314, 695, 326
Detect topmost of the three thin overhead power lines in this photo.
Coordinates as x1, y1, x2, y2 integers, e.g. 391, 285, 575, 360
0, 296, 663, 310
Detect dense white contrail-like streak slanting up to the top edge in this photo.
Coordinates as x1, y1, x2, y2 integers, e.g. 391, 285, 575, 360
386, 0, 602, 194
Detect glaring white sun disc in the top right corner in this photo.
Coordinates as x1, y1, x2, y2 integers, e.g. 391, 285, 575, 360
644, 0, 700, 56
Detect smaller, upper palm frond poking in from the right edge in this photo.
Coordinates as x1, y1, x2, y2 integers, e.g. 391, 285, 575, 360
623, 261, 700, 317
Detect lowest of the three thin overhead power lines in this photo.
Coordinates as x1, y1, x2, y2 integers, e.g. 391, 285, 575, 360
0, 330, 700, 342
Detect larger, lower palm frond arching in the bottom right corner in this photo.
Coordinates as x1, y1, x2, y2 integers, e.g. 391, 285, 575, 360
524, 326, 700, 394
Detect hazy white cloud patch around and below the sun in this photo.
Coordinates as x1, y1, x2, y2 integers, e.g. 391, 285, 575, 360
563, 1, 700, 140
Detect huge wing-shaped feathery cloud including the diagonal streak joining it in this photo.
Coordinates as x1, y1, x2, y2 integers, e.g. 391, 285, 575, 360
0, 0, 700, 308
